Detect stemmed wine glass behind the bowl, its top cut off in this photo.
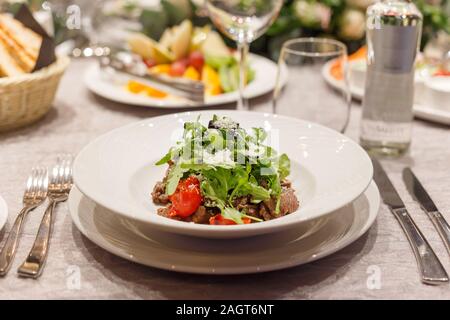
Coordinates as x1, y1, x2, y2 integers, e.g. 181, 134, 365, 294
206, 0, 283, 110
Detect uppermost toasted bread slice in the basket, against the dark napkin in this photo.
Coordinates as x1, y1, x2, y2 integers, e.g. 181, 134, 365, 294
0, 14, 42, 61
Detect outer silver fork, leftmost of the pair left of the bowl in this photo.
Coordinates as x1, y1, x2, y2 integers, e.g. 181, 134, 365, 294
0, 167, 48, 276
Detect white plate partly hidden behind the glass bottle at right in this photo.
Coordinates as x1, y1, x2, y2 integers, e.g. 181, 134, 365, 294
322, 60, 450, 125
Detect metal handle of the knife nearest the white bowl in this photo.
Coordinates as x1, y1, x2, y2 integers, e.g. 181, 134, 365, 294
391, 208, 448, 285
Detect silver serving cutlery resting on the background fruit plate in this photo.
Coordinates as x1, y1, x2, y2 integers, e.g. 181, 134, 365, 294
99, 49, 205, 104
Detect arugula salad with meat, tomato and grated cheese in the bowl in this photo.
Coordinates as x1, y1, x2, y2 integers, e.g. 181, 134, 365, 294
151, 115, 299, 225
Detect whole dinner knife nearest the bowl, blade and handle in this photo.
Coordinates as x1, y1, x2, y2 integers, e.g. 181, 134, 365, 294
372, 158, 448, 285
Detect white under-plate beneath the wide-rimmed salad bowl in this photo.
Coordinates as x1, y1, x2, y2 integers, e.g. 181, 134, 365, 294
69, 183, 380, 274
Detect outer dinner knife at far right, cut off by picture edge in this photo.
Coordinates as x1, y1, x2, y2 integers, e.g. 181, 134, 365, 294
403, 168, 450, 254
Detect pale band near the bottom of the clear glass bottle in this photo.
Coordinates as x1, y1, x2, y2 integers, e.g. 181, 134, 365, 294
361, 119, 412, 143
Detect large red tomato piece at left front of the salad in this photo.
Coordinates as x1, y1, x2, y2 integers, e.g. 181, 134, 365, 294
169, 176, 202, 218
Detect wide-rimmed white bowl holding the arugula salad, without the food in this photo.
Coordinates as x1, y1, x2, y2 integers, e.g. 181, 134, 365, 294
74, 110, 373, 238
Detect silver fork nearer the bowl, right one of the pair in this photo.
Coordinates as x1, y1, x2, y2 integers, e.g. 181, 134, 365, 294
17, 155, 73, 278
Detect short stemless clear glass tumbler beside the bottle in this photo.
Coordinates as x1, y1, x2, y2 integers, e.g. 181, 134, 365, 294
273, 38, 351, 133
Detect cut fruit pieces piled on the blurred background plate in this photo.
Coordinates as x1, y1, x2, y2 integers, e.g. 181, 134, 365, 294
126, 20, 255, 99
